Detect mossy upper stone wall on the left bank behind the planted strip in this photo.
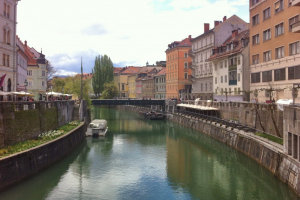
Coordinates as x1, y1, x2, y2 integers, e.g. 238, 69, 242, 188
0, 101, 74, 147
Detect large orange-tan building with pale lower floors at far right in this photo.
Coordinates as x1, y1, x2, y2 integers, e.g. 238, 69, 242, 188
250, 0, 300, 103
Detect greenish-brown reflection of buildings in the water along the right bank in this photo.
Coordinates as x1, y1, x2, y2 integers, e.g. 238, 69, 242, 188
166, 125, 297, 199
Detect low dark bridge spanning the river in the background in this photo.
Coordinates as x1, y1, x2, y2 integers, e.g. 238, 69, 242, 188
92, 99, 165, 106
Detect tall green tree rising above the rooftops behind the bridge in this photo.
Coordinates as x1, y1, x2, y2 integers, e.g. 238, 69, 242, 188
92, 55, 114, 96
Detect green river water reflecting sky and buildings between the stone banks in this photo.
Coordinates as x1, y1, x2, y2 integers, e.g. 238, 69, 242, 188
0, 107, 297, 200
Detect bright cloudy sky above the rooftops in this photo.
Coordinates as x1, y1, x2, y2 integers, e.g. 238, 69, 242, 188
17, 0, 249, 75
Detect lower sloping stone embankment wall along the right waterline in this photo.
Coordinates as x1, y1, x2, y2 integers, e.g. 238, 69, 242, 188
124, 106, 300, 196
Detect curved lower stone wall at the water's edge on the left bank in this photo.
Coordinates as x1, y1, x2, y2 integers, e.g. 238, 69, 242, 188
0, 123, 86, 190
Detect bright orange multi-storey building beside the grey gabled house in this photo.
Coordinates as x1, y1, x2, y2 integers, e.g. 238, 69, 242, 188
166, 36, 192, 99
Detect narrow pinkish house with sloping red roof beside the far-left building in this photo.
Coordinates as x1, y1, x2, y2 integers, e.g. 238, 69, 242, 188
16, 36, 28, 91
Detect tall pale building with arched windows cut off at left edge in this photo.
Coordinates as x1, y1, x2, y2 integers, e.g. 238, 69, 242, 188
0, 0, 18, 92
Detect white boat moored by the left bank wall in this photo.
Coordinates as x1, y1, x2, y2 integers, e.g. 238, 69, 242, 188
86, 119, 108, 136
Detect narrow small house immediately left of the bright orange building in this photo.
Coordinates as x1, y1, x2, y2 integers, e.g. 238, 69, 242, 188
154, 68, 166, 99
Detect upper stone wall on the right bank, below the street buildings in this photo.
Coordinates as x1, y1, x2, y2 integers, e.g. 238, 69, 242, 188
185, 101, 283, 138
